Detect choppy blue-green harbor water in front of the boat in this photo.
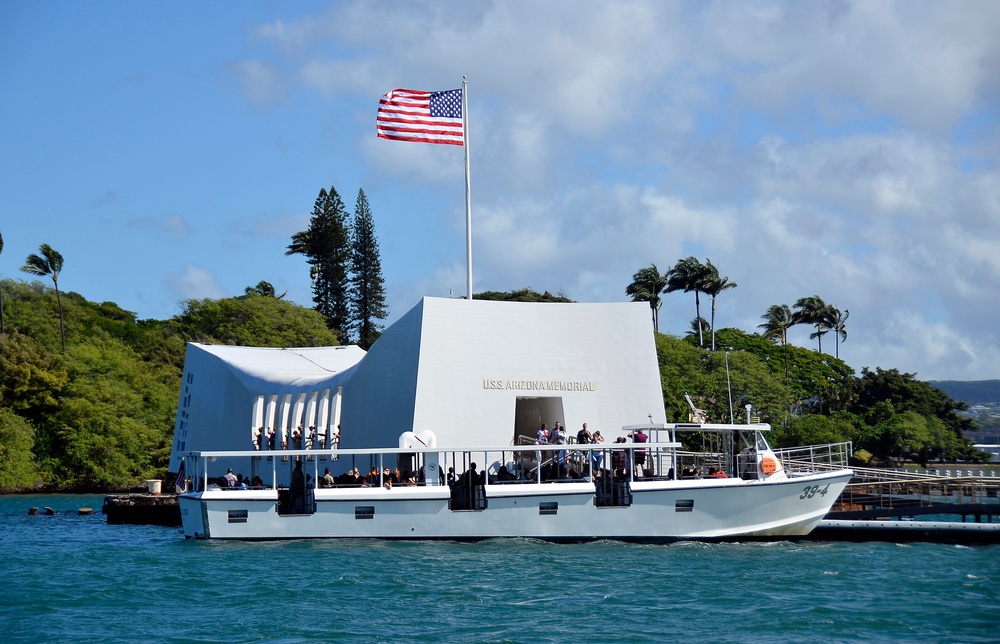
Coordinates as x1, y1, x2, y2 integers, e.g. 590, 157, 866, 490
0, 495, 1000, 643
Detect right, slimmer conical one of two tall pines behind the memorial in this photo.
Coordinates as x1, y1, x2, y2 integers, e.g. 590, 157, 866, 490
349, 190, 388, 350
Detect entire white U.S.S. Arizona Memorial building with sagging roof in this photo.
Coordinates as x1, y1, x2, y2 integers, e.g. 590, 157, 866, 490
169, 297, 665, 472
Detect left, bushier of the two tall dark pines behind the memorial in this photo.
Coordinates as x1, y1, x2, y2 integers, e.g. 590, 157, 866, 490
285, 186, 351, 344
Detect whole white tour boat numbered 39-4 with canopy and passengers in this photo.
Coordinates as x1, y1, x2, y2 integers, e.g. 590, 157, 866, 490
178, 423, 853, 542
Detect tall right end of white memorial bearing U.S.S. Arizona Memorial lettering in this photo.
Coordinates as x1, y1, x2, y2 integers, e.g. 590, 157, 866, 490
341, 298, 665, 447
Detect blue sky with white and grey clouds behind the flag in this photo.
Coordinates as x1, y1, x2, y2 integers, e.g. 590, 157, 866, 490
0, 0, 1000, 380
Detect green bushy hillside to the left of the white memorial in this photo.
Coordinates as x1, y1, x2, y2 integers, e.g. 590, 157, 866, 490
0, 280, 337, 490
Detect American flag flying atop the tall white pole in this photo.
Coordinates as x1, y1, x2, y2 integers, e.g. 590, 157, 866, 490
375, 89, 464, 145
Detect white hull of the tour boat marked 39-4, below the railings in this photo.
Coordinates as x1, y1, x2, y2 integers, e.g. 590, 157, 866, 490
179, 470, 852, 542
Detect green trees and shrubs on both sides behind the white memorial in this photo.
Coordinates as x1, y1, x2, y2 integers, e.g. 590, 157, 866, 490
0, 280, 982, 491
